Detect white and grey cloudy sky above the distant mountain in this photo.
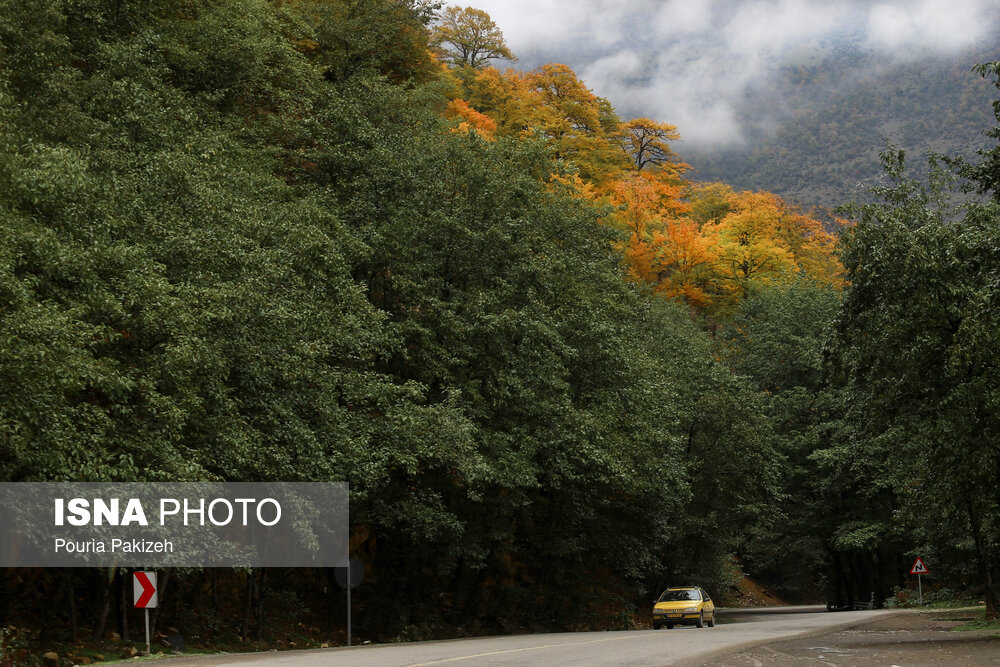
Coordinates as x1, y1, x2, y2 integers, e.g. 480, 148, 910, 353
458, 0, 1000, 144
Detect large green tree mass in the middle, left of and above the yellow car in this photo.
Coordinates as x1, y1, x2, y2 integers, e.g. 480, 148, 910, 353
304, 79, 771, 623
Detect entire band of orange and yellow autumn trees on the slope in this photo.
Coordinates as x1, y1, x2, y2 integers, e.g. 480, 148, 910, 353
434, 56, 842, 320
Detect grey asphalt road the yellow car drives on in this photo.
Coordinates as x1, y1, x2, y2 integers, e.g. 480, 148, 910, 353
164, 607, 897, 667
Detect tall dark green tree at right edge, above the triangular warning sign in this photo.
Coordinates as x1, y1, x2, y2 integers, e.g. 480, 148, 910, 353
837, 151, 1000, 614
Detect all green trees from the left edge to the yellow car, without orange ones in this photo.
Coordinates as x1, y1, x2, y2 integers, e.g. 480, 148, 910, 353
0, 0, 777, 636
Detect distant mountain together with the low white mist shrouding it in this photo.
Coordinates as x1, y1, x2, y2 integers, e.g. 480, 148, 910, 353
508, 0, 1000, 208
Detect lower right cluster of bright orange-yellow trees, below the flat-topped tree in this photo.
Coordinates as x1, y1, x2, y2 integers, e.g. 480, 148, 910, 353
612, 183, 842, 319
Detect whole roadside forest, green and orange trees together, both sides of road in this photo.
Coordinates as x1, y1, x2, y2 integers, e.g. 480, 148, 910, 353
0, 0, 1000, 656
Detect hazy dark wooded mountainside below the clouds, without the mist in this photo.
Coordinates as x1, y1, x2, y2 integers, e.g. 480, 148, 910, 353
679, 44, 997, 207
